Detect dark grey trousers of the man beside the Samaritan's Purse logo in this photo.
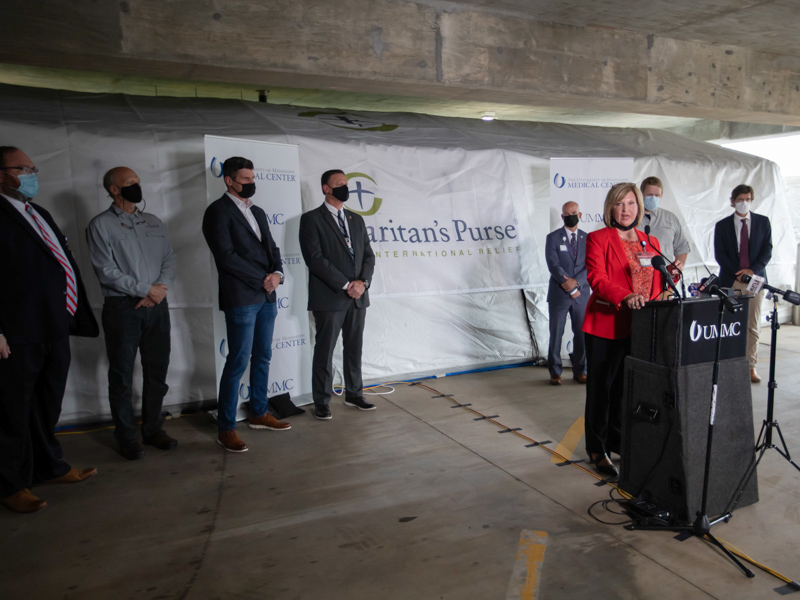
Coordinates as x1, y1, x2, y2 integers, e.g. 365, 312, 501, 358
311, 302, 367, 406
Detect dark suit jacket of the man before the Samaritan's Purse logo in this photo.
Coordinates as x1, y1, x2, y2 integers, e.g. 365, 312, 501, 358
300, 204, 375, 311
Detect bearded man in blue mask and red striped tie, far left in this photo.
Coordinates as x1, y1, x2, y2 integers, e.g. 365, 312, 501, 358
0, 146, 100, 512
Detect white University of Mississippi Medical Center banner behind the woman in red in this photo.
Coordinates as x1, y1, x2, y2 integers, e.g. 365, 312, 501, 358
550, 158, 633, 233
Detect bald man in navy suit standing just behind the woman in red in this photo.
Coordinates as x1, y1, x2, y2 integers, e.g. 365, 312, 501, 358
545, 202, 590, 385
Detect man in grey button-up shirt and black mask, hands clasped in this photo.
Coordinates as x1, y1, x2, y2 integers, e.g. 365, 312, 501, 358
86, 167, 178, 460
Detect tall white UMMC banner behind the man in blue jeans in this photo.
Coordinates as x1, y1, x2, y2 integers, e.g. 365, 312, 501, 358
205, 135, 313, 410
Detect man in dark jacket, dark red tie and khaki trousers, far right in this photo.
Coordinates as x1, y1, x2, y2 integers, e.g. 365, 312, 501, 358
714, 184, 772, 383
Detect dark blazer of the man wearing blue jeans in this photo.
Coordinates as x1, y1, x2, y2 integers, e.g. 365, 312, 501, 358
203, 194, 283, 310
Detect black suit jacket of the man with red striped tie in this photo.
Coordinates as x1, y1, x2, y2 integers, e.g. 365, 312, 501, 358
0, 196, 100, 342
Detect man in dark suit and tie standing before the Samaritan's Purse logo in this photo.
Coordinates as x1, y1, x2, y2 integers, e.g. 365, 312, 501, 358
300, 170, 375, 420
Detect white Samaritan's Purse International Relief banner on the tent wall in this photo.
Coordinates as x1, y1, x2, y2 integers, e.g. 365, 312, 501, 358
300, 140, 532, 299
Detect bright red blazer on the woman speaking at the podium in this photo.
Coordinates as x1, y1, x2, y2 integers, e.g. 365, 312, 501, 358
583, 227, 661, 340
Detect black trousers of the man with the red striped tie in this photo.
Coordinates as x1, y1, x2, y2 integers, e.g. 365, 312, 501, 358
0, 337, 70, 498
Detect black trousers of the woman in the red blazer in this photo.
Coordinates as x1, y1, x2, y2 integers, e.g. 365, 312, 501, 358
584, 333, 631, 457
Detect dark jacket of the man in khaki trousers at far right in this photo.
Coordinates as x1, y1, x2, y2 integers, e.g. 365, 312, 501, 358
714, 211, 772, 287
